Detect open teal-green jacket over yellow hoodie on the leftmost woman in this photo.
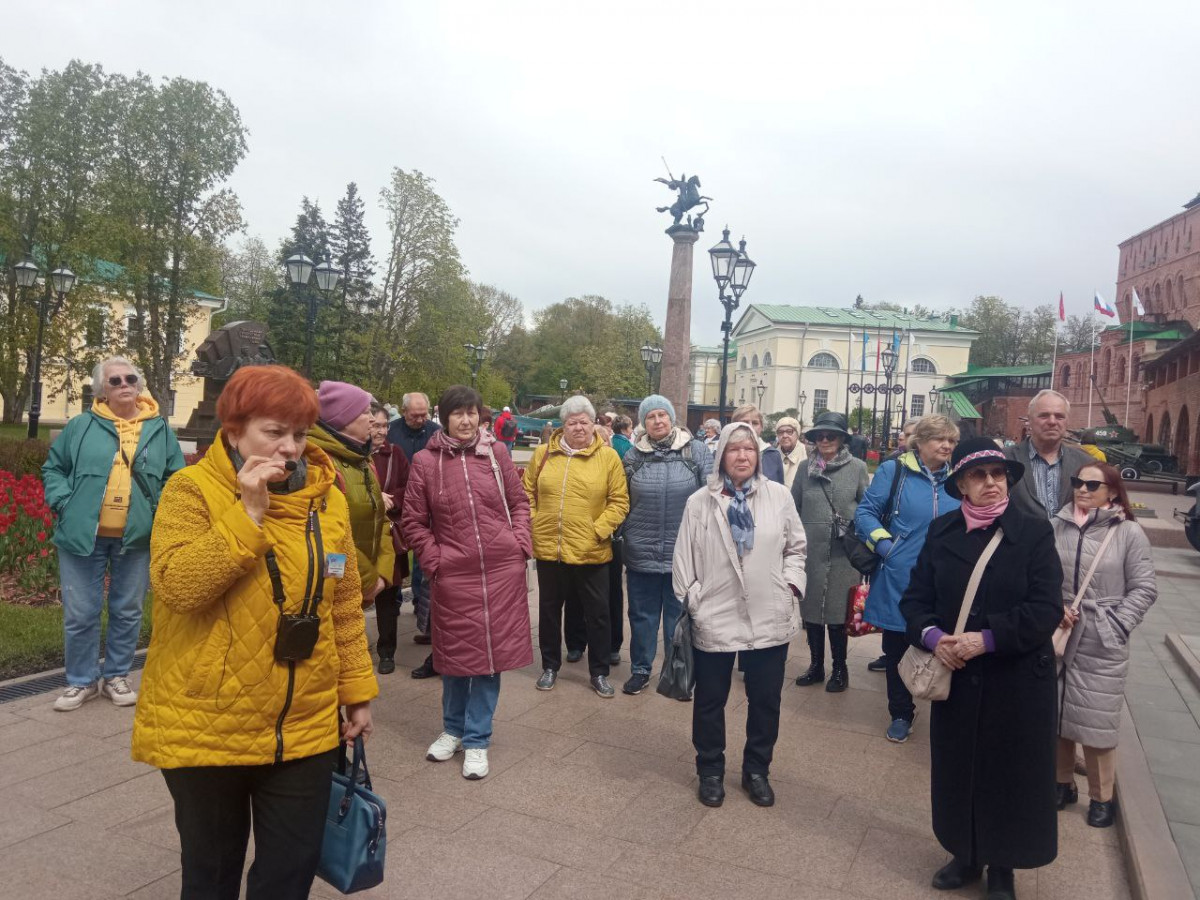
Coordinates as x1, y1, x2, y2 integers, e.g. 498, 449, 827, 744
42, 412, 186, 557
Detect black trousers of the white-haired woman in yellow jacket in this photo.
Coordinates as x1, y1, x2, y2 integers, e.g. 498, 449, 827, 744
538, 559, 610, 677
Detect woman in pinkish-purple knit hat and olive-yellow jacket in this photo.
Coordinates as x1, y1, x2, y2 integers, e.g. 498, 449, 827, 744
308, 382, 396, 606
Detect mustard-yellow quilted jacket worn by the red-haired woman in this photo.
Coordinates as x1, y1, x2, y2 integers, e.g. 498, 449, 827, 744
133, 433, 378, 769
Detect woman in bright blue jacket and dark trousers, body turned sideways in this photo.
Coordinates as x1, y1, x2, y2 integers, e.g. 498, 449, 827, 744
854, 415, 959, 744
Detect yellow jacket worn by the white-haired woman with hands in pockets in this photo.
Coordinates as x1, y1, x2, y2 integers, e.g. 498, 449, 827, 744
524, 428, 629, 565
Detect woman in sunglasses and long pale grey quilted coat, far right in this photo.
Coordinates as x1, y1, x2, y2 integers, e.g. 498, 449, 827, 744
1054, 463, 1158, 828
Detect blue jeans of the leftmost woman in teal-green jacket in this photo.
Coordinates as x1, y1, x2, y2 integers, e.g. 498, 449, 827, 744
59, 538, 150, 688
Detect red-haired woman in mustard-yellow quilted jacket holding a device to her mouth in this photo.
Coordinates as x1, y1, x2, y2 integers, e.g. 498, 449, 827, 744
133, 366, 378, 898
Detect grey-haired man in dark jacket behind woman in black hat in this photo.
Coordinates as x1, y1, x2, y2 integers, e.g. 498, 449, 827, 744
1004, 390, 1094, 520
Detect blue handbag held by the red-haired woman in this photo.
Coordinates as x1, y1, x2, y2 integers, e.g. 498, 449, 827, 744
317, 737, 388, 894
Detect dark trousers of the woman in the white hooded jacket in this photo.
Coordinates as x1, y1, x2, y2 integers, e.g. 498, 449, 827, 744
691, 643, 787, 775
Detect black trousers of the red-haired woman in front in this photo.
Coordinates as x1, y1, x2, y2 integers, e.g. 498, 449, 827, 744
162, 748, 337, 900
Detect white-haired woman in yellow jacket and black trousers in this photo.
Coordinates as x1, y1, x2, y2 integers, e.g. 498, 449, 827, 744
524, 396, 629, 698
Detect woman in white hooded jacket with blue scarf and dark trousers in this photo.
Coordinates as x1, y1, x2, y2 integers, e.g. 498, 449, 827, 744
672, 422, 805, 806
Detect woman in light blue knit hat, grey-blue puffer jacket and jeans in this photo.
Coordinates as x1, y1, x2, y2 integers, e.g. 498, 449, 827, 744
622, 394, 713, 694
